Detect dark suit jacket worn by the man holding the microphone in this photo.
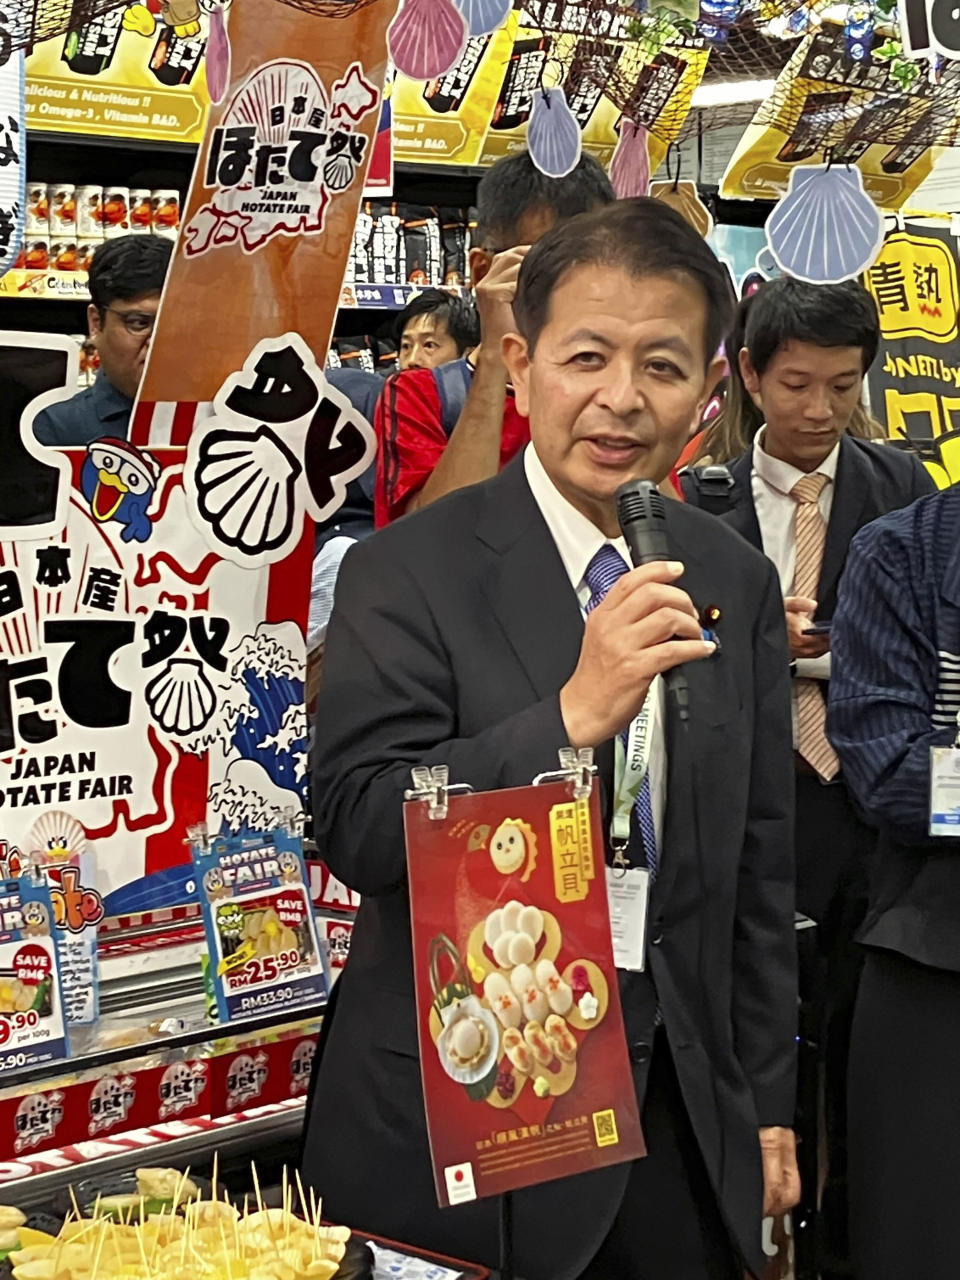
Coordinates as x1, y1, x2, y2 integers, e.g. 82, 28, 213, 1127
303, 460, 796, 1280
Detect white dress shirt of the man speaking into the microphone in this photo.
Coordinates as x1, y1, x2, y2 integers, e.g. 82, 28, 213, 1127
524, 444, 667, 859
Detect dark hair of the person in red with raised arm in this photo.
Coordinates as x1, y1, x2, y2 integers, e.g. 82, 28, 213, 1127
476, 151, 616, 252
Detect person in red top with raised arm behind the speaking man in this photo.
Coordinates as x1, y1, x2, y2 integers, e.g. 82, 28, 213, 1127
374, 152, 614, 529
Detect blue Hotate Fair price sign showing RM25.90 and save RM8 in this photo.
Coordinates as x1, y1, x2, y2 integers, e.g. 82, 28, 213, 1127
192, 831, 330, 1023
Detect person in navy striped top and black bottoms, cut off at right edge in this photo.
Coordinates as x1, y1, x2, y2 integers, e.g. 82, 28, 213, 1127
829, 485, 960, 1280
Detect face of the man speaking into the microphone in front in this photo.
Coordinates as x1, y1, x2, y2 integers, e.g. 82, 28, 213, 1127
503, 265, 723, 534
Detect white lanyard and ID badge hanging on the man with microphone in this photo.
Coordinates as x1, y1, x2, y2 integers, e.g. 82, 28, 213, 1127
607, 684, 658, 973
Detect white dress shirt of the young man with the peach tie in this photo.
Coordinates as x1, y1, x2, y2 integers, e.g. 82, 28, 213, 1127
750, 426, 840, 680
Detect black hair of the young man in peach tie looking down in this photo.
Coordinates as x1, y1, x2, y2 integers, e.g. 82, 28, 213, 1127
744, 275, 879, 374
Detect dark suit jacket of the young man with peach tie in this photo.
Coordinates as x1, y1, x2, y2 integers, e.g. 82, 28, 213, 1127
696, 435, 936, 621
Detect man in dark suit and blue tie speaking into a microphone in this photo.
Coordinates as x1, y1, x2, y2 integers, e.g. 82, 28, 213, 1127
303, 200, 797, 1280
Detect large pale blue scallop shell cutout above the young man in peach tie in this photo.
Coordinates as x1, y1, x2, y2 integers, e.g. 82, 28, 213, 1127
767, 165, 883, 284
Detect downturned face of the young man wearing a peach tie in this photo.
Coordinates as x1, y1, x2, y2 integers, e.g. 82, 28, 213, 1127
740, 340, 863, 471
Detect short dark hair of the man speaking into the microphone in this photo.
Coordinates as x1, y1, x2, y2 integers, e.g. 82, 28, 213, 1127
513, 196, 733, 364
